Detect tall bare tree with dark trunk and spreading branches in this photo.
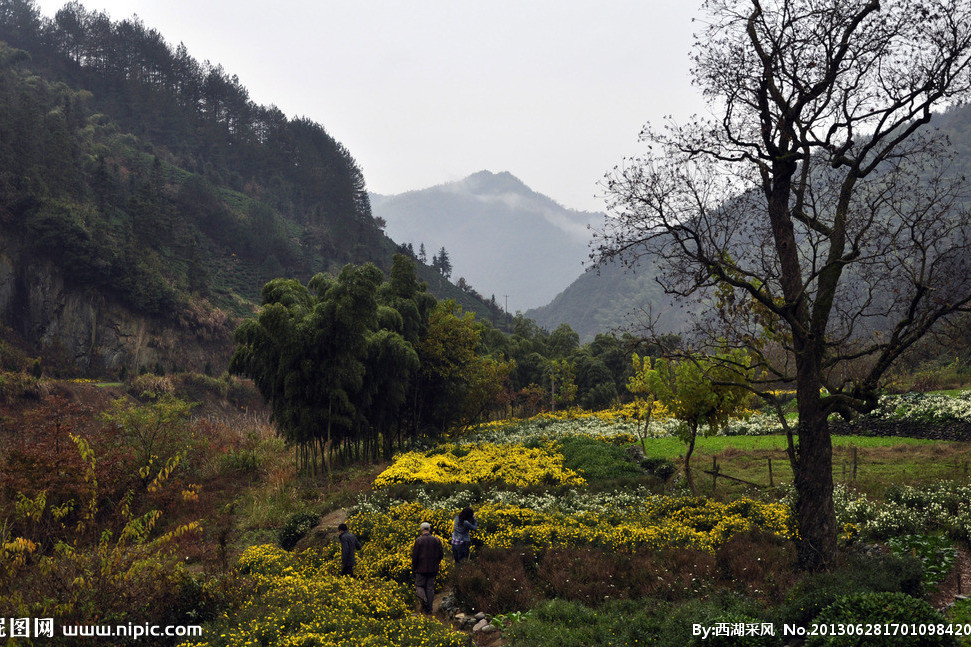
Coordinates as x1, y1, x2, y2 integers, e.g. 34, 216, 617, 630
595, 0, 971, 569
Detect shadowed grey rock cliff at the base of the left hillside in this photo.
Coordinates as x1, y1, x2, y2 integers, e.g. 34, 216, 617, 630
0, 244, 233, 376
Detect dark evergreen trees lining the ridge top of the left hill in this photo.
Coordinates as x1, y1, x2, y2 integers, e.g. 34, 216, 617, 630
0, 0, 377, 237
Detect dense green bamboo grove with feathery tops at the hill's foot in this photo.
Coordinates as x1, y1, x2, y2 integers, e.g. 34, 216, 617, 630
230, 254, 513, 473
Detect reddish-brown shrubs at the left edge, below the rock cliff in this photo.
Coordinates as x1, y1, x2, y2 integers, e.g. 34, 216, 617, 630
0, 396, 232, 552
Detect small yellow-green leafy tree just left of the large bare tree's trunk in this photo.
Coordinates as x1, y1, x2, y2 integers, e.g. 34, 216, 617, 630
630, 351, 750, 494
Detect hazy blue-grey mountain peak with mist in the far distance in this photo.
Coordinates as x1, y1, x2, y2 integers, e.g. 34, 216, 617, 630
370, 171, 603, 311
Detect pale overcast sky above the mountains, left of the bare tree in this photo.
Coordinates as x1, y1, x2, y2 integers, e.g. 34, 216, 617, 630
39, 0, 702, 210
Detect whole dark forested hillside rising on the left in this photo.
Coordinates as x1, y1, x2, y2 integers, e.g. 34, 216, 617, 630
0, 0, 502, 373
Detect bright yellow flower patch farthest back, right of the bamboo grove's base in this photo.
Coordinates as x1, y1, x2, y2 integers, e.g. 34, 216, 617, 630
374, 443, 584, 488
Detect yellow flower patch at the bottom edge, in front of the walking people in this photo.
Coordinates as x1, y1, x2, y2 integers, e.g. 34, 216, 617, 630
183, 545, 468, 647
